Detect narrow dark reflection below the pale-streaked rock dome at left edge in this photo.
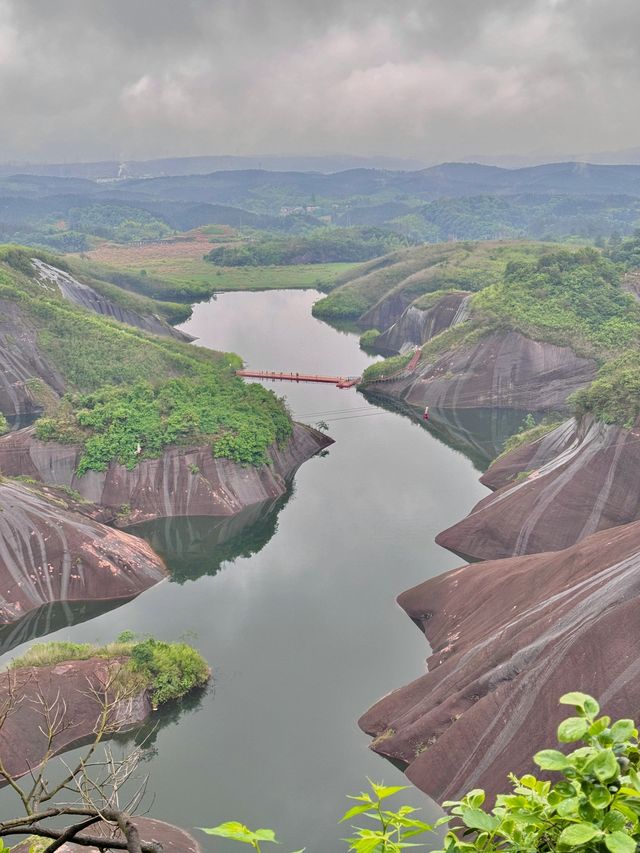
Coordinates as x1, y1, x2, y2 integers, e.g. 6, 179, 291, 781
0, 598, 131, 655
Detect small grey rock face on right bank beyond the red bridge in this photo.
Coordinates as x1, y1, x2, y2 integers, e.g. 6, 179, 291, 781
374, 291, 471, 354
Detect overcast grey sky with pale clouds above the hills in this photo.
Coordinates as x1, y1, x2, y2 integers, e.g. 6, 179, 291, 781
0, 0, 640, 162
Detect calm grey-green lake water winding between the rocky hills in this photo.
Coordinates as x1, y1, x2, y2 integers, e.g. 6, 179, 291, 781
2, 291, 486, 853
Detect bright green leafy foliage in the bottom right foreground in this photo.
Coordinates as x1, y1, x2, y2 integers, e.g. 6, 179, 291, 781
205, 692, 640, 853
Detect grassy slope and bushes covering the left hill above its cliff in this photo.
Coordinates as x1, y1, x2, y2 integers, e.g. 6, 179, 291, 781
0, 249, 292, 472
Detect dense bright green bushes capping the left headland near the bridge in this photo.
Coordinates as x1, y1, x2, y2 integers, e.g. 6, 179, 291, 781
36, 372, 292, 475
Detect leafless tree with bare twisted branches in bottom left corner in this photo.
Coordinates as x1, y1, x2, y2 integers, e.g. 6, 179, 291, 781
0, 660, 162, 853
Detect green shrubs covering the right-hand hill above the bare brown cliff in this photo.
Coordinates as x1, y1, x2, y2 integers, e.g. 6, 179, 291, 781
360, 245, 640, 432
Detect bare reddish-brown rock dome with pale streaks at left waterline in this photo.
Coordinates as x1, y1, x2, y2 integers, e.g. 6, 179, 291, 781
0, 480, 166, 624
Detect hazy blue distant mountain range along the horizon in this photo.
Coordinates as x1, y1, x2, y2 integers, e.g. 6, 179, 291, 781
0, 158, 640, 250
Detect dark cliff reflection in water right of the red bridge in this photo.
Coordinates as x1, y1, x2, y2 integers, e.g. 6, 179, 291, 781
363, 391, 529, 471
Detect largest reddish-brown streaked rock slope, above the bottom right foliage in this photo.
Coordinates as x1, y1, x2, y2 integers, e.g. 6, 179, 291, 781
360, 522, 640, 802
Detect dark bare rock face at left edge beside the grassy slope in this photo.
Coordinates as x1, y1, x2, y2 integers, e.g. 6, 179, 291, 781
0, 299, 64, 420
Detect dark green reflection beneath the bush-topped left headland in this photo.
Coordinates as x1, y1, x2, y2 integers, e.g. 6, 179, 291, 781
129, 488, 293, 583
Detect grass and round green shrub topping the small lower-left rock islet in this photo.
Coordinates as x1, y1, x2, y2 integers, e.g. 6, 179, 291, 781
11, 631, 211, 707
